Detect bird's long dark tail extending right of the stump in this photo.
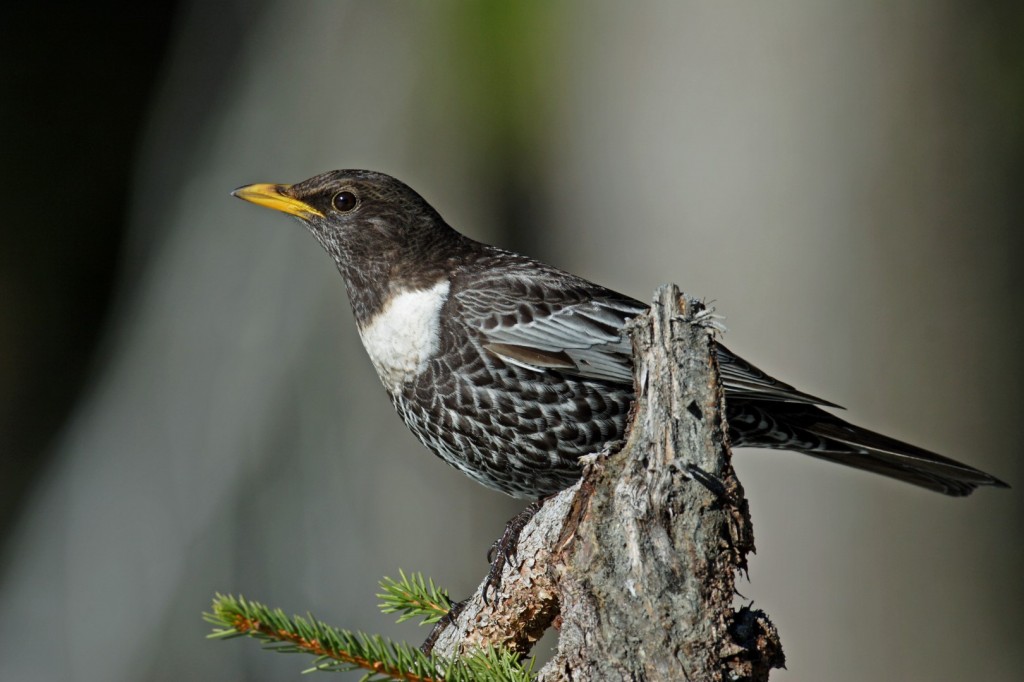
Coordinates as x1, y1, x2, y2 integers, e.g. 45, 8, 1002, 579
728, 400, 1010, 497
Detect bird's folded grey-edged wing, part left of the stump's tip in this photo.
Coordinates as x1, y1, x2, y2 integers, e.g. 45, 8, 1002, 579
453, 272, 647, 384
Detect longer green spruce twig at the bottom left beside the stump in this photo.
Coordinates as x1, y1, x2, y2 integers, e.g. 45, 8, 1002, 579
204, 585, 532, 682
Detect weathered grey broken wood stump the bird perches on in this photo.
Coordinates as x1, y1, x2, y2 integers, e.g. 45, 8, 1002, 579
434, 286, 784, 682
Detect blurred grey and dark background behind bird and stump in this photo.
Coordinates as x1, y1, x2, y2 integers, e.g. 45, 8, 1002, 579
0, 0, 1024, 682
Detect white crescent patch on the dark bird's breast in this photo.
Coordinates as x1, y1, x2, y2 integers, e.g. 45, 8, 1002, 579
359, 280, 451, 391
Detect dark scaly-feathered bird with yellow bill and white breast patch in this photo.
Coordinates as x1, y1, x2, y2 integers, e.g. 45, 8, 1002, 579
231, 170, 1008, 501
